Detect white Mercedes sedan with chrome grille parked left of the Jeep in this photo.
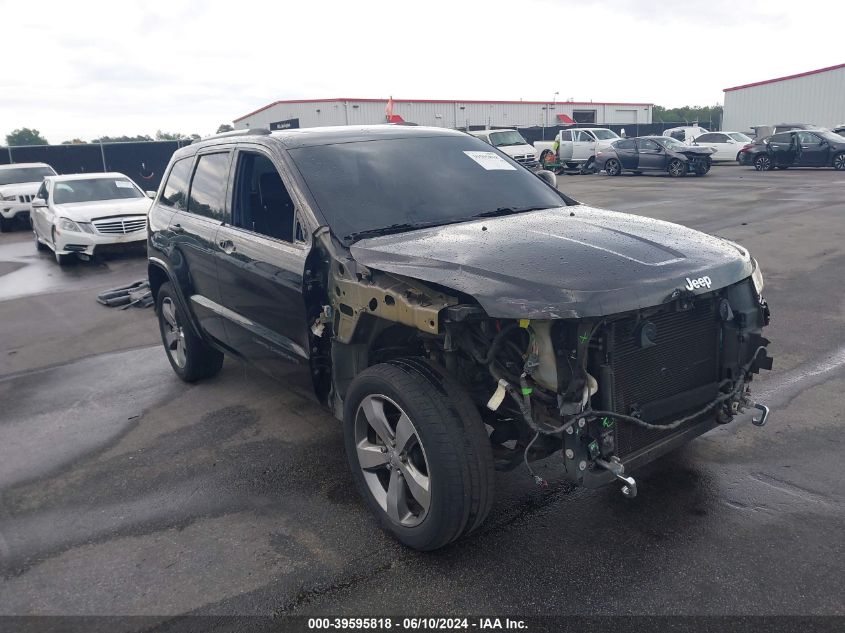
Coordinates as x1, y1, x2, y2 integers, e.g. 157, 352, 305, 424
32, 172, 154, 264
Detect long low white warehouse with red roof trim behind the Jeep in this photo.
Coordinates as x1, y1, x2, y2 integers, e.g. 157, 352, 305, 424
234, 98, 652, 129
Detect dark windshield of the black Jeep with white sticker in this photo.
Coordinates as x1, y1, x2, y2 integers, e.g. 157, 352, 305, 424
290, 135, 574, 243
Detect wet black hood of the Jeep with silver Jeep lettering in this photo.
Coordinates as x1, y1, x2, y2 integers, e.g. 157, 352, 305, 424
350, 205, 752, 319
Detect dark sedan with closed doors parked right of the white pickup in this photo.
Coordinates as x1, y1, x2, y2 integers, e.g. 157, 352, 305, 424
596, 136, 716, 178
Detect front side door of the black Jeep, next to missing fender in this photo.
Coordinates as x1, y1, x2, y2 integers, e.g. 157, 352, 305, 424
217, 146, 310, 377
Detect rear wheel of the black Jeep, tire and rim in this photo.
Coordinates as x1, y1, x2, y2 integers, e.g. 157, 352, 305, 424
156, 282, 223, 382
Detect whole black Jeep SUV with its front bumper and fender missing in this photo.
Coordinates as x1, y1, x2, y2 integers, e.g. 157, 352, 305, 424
149, 125, 771, 550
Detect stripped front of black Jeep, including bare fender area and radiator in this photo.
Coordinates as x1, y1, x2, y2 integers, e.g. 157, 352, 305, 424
306, 225, 772, 496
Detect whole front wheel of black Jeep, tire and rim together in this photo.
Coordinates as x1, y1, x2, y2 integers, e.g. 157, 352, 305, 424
343, 359, 493, 551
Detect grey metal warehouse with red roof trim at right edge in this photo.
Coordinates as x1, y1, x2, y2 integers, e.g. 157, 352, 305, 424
722, 64, 845, 132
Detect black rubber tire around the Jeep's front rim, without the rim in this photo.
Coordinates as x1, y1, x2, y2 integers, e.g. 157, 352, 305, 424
343, 359, 494, 551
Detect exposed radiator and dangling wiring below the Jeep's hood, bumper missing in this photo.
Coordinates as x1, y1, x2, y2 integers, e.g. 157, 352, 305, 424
444, 278, 772, 496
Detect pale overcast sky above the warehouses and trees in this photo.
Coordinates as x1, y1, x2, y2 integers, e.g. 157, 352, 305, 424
0, 0, 845, 143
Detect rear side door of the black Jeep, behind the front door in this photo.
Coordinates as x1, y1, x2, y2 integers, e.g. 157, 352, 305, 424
165, 147, 232, 342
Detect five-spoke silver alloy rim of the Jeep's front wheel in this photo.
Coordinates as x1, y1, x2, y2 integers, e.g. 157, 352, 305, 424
355, 394, 431, 527
